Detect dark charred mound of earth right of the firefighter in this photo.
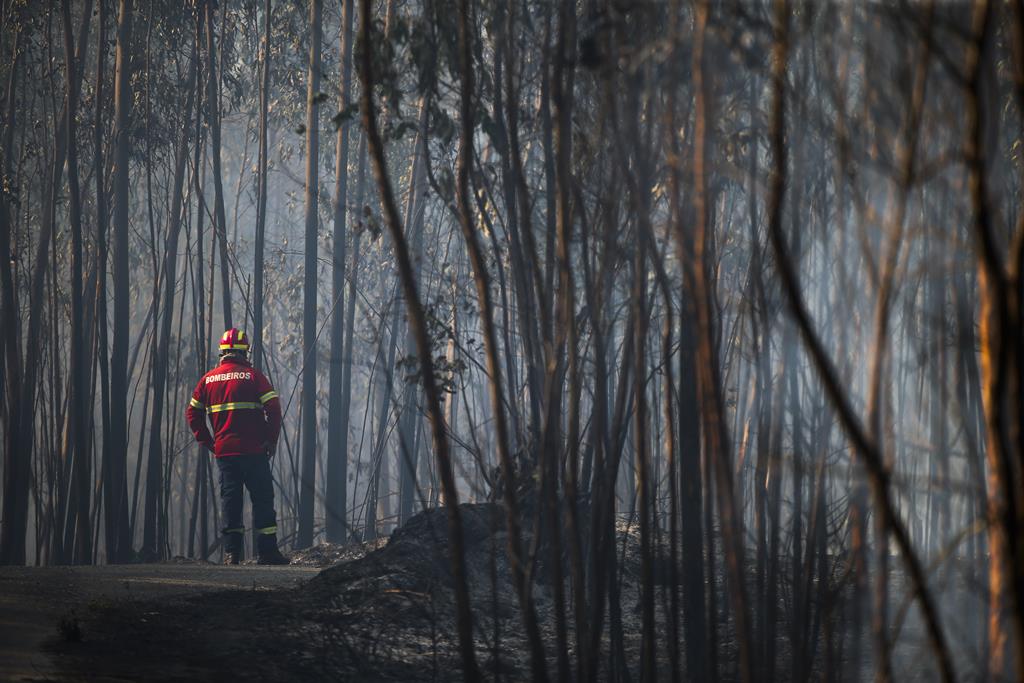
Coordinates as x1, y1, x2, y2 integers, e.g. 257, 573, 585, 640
306, 504, 527, 681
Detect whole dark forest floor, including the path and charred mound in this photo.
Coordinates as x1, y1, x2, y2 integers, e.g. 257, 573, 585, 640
0, 504, 974, 682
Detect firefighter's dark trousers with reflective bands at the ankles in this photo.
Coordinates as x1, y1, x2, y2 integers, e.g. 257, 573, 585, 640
216, 454, 278, 553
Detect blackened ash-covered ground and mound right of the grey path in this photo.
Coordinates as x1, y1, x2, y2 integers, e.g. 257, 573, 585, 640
51, 504, 655, 681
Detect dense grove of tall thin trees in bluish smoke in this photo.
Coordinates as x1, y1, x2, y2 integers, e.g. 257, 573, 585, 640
0, 0, 1024, 681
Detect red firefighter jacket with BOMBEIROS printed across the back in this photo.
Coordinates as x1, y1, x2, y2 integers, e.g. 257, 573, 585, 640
185, 356, 281, 458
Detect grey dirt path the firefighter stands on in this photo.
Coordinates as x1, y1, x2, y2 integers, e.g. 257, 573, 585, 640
0, 564, 318, 681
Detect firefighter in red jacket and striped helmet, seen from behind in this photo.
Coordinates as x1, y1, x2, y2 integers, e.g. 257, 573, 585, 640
185, 328, 288, 564
